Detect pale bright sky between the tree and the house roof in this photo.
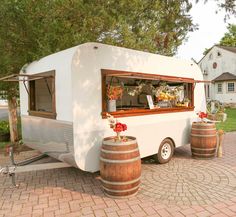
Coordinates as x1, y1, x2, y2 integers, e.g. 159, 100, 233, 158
176, 0, 236, 62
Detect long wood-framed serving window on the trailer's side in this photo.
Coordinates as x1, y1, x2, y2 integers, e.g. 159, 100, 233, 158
102, 69, 194, 118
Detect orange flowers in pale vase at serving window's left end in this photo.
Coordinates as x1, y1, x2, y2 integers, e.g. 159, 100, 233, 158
107, 85, 123, 112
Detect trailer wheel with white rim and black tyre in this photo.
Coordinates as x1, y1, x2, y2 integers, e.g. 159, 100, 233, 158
155, 139, 174, 164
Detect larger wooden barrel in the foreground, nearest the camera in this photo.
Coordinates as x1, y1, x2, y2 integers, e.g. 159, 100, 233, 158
100, 136, 141, 198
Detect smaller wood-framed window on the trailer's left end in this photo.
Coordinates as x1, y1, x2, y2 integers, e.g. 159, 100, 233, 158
29, 71, 56, 119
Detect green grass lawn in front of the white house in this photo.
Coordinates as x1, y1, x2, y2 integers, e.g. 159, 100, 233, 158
216, 108, 236, 132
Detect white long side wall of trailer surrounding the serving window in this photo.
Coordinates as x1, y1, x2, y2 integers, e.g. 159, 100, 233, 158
72, 43, 205, 171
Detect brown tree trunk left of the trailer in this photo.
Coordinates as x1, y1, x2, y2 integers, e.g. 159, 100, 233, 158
8, 97, 19, 143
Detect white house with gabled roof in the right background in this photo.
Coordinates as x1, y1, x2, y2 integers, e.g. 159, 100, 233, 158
198, 45, 236, 105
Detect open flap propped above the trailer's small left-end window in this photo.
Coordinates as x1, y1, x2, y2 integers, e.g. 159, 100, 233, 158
0, 74, 53, 82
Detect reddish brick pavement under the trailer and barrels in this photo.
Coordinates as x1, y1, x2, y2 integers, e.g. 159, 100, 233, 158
0, 133, 236, 217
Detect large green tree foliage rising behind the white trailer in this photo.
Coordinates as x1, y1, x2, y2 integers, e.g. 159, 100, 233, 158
0, 0, 194, 80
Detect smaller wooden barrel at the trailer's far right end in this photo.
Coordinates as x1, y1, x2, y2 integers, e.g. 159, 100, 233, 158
191, 122, 217, 159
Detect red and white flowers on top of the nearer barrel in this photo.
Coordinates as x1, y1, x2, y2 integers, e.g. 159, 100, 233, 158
107, 113, 127, 141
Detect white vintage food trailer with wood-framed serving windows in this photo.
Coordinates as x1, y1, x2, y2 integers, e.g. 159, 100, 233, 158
2, 43, 206, 172
